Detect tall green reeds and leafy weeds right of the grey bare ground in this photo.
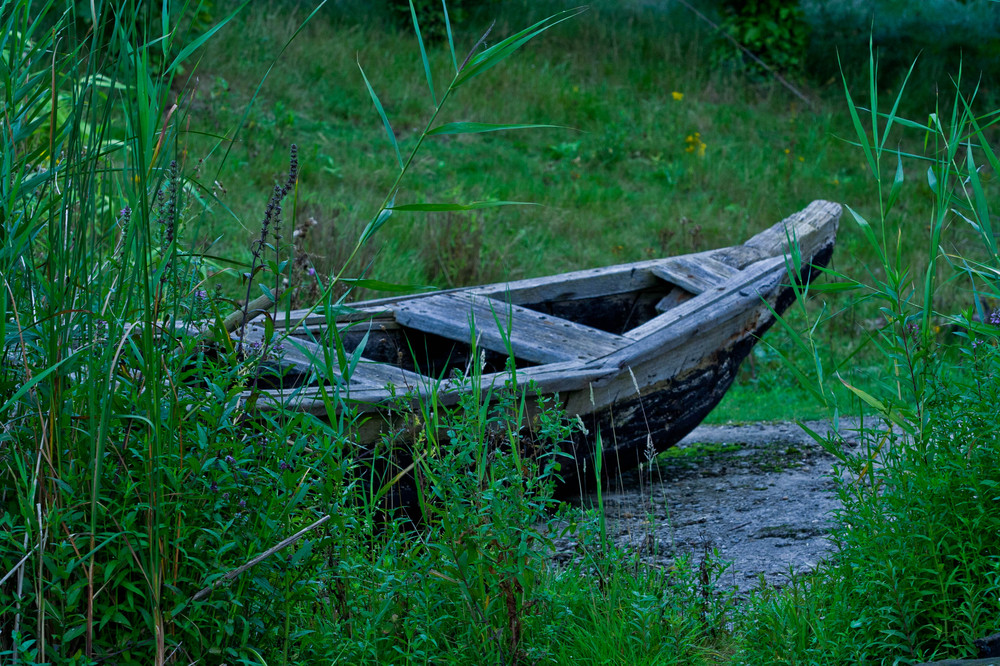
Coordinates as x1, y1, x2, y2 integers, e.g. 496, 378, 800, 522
747, 44, 1000, 664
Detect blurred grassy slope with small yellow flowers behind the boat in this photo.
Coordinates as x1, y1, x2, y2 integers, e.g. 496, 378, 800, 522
181, 0, 1000, 420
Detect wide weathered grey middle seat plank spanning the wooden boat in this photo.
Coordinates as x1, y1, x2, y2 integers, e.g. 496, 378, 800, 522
388, 292, 630, 363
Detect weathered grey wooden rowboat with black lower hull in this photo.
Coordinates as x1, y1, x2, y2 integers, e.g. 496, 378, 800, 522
245, 201, 841, 488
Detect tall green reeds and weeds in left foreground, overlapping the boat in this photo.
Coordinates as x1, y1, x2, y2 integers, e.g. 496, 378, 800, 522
0, 0, 736, 664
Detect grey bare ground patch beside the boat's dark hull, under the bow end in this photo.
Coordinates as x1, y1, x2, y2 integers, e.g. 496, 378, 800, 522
557, 422, 853, 591
